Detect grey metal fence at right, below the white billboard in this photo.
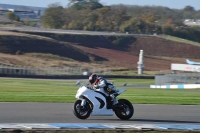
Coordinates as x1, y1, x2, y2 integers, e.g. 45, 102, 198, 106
155, 72, 200, 85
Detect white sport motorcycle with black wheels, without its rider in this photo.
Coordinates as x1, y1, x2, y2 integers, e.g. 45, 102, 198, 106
73, 81, 134, 120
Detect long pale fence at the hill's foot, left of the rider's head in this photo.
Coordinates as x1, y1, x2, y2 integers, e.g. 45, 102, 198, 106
0, 65, 111, 75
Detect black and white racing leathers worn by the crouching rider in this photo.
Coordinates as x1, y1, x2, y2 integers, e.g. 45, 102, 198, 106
93, 77, 118, 105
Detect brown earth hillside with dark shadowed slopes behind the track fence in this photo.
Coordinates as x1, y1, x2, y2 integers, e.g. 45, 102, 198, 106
0, 31, 200, 75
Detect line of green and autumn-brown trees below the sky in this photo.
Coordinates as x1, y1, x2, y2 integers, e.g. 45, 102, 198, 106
38, 0, 200, 42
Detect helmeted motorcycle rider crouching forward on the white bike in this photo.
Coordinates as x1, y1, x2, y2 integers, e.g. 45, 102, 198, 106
89, 74, 118, 105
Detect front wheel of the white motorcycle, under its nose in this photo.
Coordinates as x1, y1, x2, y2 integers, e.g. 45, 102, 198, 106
73, 100, 92, 119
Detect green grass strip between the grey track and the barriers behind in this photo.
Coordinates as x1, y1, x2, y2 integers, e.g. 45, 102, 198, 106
0, 78, 200, 105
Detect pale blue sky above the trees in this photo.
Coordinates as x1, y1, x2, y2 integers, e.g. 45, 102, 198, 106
0, 0, 200, 10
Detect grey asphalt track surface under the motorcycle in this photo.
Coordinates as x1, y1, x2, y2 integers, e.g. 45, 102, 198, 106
0, 103, 200, 124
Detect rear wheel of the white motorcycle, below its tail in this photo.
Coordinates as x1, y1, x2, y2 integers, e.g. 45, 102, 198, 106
114, 99, 134, 120
